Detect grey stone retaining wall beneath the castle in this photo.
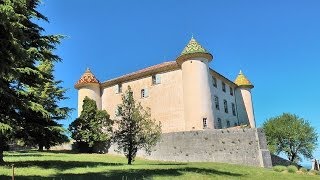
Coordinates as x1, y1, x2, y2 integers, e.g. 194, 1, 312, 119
109, 129, 272, 167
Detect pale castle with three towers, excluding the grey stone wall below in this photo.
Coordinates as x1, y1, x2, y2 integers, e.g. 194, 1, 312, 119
75, 37, 255, 133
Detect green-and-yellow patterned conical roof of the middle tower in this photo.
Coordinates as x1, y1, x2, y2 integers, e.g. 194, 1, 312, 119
176, 37, 213, 63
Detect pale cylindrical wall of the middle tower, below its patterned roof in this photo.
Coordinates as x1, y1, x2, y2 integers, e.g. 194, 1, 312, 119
181, 58, 214, 131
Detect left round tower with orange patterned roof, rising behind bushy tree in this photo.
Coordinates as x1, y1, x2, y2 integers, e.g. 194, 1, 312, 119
74, 68, 101, 116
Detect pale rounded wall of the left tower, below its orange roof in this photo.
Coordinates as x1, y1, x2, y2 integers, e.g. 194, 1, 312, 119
78, 84, 101, 116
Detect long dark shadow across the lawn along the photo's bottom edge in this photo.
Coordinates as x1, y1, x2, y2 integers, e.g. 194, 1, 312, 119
0, 167, 243, 180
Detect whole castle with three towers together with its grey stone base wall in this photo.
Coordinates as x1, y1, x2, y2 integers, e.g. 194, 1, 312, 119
75, 38, 273, 167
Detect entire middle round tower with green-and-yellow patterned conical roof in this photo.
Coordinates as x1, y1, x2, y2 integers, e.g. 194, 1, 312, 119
176, 37, 214, 131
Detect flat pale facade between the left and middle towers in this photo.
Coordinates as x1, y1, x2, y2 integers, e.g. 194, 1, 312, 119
102, 70, 185, 132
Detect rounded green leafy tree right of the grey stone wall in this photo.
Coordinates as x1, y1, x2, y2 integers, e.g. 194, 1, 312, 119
263, 113, 318, 163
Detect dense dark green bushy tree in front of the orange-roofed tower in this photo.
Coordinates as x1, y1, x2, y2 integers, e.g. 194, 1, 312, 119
69, 96, 113, 153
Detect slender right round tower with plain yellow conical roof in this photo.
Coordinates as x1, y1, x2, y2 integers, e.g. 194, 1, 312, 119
234, 70, 256, 128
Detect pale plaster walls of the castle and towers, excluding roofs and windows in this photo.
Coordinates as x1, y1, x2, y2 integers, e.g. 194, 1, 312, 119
78, 63, 255, 133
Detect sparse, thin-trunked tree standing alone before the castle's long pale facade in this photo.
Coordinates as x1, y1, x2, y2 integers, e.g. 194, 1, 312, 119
114, 86, 161, 164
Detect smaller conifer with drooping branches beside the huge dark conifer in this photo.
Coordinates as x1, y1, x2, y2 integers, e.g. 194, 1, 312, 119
15, 61, 71, 151
